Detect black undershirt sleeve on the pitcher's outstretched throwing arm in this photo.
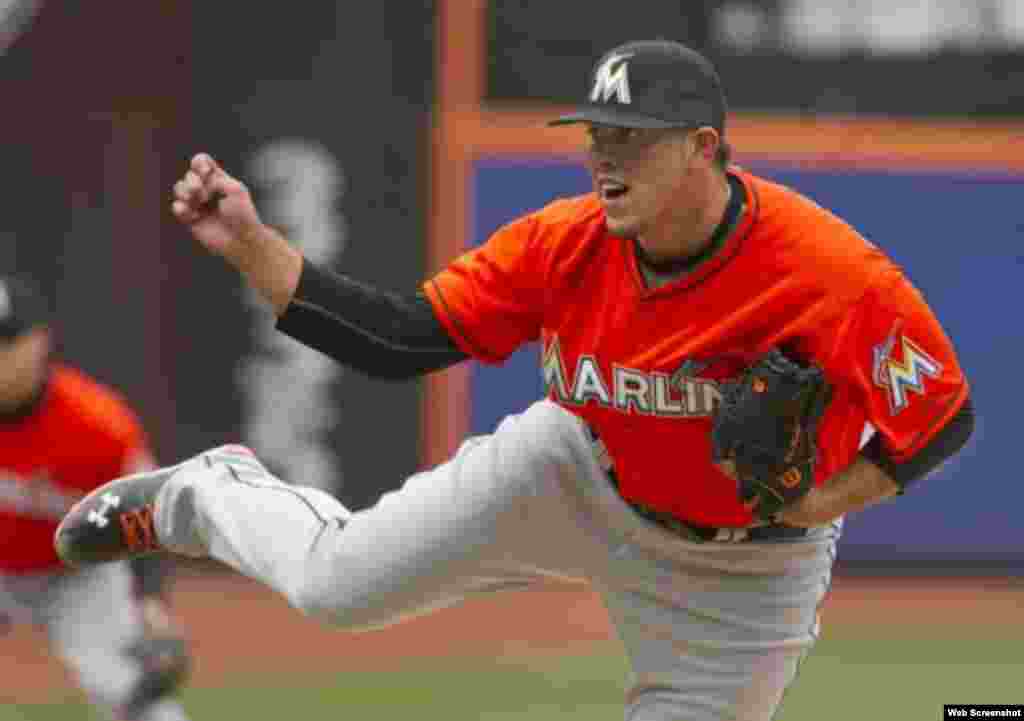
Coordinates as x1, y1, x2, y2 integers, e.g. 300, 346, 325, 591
276, 259, 469, 380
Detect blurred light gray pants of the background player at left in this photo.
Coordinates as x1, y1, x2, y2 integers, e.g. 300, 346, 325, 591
0, 563, 187, 721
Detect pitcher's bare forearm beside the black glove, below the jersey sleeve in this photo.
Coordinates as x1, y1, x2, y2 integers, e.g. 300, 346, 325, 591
779, 456, 899, 526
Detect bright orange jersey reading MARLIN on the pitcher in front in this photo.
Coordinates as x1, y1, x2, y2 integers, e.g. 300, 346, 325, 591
424, 169, 968, 526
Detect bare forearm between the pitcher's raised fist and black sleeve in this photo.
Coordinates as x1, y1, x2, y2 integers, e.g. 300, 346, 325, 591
227, 224, 302, 316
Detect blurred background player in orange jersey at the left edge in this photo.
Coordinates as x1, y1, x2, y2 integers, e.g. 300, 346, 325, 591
0, 275, 188, 721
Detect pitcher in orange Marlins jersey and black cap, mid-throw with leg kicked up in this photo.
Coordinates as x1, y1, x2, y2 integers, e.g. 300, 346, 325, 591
55, 41, 973, 721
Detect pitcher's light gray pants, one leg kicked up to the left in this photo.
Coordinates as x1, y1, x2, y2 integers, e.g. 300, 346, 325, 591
157, 401, 839, 721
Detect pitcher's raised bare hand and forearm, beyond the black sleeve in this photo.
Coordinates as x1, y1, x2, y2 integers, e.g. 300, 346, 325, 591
171, 153, 302, 314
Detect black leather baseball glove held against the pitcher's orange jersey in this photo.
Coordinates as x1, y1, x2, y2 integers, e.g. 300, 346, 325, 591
712, 349, 831, 520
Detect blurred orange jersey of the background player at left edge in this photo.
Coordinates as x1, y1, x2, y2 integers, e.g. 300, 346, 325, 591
0, 365, 153, 574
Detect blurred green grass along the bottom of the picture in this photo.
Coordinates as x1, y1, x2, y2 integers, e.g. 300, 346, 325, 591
0, 630, 1024, 721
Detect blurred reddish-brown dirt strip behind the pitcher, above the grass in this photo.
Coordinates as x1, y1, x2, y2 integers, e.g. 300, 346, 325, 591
0, 575, 1024, 704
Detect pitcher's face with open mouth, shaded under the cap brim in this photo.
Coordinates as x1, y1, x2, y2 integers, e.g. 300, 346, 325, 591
587, 124, 706, 256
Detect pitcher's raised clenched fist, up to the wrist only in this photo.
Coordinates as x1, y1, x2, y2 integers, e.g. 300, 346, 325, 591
171, 153, 262, 260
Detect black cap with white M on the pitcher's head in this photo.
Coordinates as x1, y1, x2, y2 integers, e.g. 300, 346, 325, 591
549, 40, 726, 135
